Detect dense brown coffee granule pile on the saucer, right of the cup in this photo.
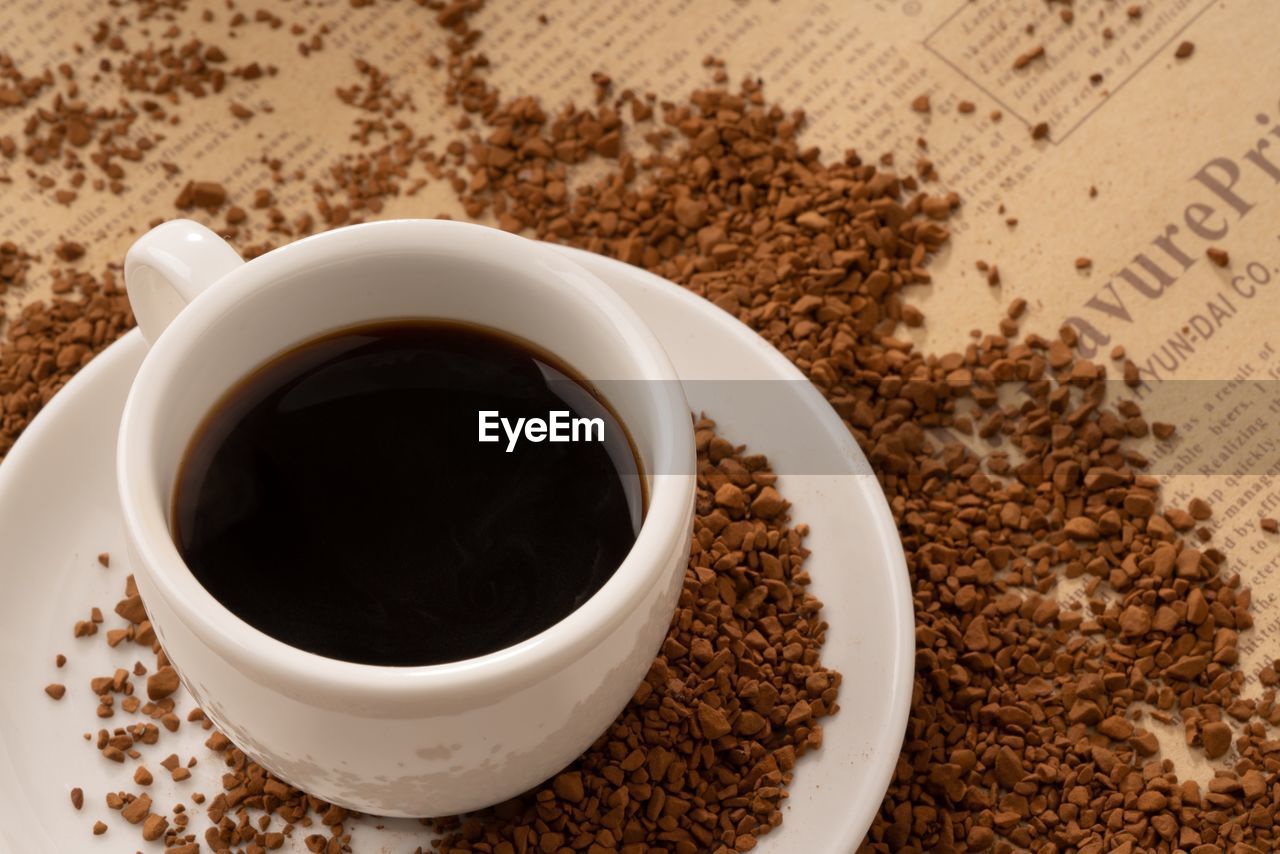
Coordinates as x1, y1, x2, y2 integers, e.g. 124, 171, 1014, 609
435, 417, 840, 853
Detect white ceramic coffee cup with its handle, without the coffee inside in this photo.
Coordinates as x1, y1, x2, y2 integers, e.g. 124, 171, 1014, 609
116, 220, 695, 817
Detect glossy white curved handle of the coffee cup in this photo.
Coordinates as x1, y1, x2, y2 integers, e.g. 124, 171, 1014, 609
124, 219, 244, 344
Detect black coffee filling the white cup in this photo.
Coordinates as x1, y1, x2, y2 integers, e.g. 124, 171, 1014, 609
173, 321, 644, 666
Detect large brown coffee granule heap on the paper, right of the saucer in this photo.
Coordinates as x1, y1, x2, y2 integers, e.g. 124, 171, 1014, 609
422, 8, 1275, 854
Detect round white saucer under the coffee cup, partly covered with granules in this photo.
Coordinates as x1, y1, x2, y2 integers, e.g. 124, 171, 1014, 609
0, 243, 914, 854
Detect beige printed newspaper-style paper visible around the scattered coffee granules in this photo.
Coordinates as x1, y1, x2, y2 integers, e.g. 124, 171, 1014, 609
0, 0, 1280, 804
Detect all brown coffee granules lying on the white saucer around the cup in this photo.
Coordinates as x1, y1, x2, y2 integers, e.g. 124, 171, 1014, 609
60, 417, 824, 854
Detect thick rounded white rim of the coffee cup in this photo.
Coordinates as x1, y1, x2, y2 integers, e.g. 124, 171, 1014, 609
116, 219, 695, 699
